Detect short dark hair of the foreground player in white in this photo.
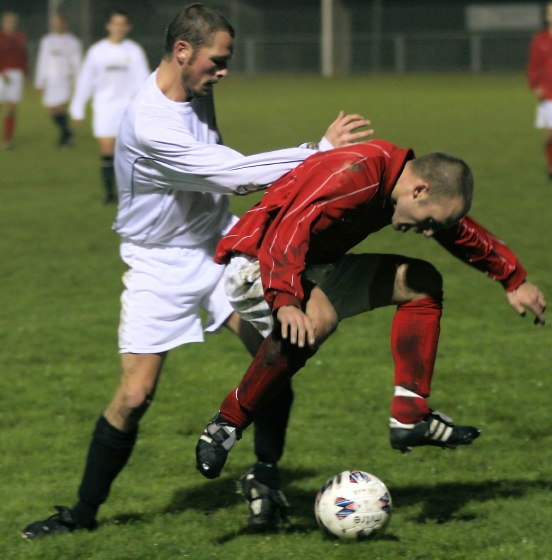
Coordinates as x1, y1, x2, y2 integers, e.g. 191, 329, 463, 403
163, 4, 235, 59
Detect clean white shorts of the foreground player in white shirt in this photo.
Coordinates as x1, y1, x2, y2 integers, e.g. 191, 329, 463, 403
119, 238, 233, 354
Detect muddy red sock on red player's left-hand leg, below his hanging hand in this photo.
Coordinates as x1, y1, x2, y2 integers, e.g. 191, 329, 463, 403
220, 334, 316, 429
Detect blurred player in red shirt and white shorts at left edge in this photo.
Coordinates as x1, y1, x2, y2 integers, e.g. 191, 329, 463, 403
0, 12, 29, 149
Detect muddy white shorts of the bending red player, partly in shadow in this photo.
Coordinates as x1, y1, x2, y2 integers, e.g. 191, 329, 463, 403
224, 253, 382, 337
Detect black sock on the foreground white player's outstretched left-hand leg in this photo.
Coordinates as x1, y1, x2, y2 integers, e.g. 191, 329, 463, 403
73, 416, 138, 525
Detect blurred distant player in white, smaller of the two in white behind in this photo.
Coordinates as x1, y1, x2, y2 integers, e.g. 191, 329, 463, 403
35, 13, 82, 148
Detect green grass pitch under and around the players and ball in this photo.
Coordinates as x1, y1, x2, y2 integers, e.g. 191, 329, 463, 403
0, 75, 552, 560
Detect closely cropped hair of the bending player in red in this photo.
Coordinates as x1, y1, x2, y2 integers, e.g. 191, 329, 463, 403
412, 152, 473, 213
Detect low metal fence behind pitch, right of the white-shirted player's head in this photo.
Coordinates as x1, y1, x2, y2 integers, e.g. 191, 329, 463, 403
238, 32, 532, 74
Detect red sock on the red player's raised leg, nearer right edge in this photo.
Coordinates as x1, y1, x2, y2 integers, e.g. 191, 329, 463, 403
391, 297, 442, 424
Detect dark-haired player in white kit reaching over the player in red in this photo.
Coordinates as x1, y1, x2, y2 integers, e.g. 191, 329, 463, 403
23, 4, 372, 538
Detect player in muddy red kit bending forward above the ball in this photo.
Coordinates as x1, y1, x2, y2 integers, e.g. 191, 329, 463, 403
196, 140, 546, 516
